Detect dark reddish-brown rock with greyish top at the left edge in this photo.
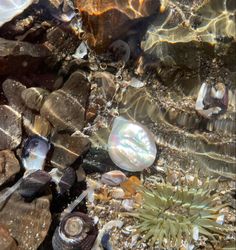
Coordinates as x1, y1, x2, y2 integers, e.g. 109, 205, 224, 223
0, 38, 49, 75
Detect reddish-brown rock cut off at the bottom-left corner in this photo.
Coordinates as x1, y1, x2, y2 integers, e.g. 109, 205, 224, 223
0, 224, 18, 250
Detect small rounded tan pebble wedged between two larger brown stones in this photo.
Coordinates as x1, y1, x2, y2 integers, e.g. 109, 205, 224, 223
21, 87, 50, 111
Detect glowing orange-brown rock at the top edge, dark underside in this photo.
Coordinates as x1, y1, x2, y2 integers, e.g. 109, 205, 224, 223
75, 0, 160, 50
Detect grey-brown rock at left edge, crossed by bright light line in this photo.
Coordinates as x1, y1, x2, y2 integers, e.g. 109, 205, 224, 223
0, 105, 22, 150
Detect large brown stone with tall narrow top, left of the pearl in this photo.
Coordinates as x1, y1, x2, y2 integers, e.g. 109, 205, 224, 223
40, 72, 90, 132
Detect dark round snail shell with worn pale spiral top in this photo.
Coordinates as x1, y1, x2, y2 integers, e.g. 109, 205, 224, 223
52, 212, 98, 250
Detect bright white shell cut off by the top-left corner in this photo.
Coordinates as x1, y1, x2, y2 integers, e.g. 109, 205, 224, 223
0, 0, 34, 27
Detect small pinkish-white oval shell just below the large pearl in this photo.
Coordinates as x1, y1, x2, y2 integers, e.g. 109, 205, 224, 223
101, 170, 127, 186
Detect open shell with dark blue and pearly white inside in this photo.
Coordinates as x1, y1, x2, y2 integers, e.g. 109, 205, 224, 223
22, 136, 50, 170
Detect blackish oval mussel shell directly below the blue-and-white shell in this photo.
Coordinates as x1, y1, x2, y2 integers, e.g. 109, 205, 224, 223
18, 170, 51, 199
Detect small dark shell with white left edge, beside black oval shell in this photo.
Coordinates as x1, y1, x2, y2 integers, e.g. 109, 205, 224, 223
50, 167, 76, 194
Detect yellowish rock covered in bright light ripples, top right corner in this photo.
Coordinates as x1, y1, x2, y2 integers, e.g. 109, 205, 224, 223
143, 0, 236, 51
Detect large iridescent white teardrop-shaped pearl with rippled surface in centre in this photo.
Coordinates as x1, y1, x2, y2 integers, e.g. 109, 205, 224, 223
108, 117, 157, 172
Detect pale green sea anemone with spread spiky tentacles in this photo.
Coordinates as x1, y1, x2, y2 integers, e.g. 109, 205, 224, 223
131, 178, 227, 247
